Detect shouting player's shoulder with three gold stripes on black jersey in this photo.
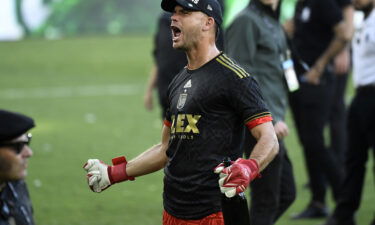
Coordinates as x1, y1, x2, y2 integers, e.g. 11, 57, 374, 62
215, 53, 250, 80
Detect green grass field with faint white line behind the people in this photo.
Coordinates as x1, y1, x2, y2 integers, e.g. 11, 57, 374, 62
0, 36, 375, 225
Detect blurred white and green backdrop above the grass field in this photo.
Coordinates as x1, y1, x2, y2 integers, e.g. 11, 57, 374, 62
0, 0, 295, 40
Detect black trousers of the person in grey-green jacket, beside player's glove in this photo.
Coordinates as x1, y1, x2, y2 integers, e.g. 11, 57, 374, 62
250, 142, 296, 225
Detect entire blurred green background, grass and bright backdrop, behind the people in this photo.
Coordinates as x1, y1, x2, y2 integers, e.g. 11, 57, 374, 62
0, 0, 375, 225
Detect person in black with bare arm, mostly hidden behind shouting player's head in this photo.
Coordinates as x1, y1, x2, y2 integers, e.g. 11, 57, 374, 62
144, 0, 224, 118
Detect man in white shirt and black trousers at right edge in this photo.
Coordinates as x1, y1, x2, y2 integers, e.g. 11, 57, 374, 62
325, 0, 375, 225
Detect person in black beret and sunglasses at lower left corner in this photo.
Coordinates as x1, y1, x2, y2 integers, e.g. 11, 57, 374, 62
0, 110, 35, 225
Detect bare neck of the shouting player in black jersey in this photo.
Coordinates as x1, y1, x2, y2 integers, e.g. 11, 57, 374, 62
186, 43, 220, 70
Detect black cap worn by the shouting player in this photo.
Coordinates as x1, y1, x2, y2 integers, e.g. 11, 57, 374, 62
161, 0, 223, 26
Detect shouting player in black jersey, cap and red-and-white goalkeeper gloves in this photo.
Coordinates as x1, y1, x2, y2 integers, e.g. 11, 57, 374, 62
84, 0, 278, 225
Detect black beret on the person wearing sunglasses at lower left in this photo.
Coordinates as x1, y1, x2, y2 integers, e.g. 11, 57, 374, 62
0, 109, 35, 142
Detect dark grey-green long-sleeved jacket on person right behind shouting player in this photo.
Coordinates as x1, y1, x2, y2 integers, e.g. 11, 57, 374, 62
225, 0, 288, 122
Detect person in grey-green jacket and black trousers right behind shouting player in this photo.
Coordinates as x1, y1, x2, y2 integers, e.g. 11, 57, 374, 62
225, 0, 298, 225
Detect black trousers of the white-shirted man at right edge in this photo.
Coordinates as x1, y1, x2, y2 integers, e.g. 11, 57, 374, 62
334, 86, 375, 220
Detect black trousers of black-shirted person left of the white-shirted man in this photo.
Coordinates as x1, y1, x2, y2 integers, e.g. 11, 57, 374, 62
290, 71, 343, 203
